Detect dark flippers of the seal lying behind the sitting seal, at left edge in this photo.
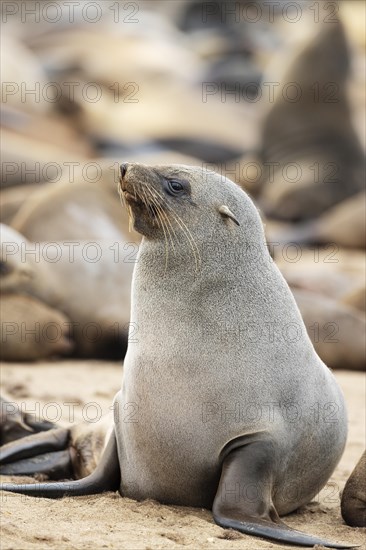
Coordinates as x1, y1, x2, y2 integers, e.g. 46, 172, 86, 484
0, 428, 73, 480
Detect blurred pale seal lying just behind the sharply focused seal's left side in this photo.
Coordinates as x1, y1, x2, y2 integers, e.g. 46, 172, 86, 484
0, 224, 134, 359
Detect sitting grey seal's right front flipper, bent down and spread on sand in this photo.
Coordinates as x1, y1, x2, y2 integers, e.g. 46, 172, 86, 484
212, 441, 354, 548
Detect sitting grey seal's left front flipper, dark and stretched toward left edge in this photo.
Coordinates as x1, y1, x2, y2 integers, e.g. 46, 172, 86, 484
0, 432, 121, 498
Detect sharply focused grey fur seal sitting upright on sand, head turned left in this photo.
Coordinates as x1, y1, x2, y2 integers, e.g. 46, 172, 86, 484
1, 164, 352, 548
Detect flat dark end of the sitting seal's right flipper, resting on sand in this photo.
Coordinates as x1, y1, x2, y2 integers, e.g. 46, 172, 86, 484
214, 516, 359, 549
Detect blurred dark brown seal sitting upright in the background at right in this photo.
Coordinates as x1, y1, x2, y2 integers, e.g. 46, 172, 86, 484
260, 20, 365, 221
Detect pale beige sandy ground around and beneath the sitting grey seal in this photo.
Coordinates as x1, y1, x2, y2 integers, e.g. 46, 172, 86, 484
1, 361, 366, 550
